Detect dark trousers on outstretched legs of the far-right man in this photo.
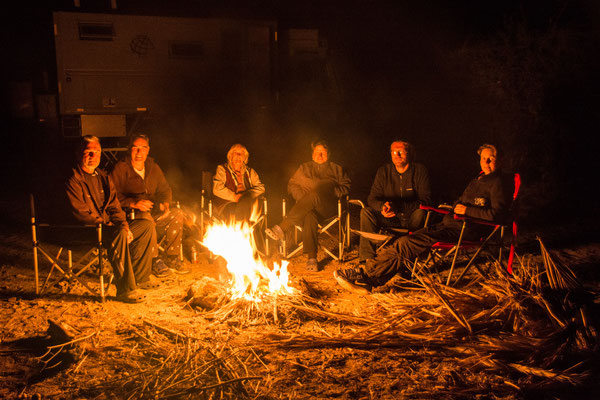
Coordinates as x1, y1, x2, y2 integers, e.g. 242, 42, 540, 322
365, 216, 481, 286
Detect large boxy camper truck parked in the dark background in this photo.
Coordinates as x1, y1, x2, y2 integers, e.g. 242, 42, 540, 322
53, 12, 277, 137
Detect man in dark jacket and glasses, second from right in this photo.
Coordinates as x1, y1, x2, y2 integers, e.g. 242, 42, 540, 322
358, 140, 431, 263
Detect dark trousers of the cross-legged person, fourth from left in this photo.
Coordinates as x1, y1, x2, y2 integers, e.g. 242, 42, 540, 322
279, 191, 337, 258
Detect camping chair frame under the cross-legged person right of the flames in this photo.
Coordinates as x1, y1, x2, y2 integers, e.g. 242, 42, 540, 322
281, 196, 350, 262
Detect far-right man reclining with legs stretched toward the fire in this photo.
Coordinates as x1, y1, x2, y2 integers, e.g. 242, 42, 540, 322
333, 144, 512, 294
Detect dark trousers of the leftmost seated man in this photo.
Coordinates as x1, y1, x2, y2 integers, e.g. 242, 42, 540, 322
107, 219, 156, 295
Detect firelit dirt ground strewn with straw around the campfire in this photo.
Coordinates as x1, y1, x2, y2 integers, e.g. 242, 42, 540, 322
0, 198, 600, 399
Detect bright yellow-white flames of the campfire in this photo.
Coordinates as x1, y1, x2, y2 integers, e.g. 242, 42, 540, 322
202, 222, 294, 301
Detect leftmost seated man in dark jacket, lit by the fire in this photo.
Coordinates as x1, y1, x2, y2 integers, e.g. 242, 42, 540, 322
66, 135, 156, 302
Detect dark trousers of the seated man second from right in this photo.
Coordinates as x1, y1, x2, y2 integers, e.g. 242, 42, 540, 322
358, 207, 426, 261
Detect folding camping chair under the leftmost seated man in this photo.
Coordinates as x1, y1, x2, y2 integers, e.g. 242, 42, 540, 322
30, 194, 113, 302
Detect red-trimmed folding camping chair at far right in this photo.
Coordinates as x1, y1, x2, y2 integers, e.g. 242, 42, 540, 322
413, 173, 521, 285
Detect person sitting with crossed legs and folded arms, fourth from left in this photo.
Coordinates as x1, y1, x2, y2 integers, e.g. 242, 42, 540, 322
266, 140, 350, 271
